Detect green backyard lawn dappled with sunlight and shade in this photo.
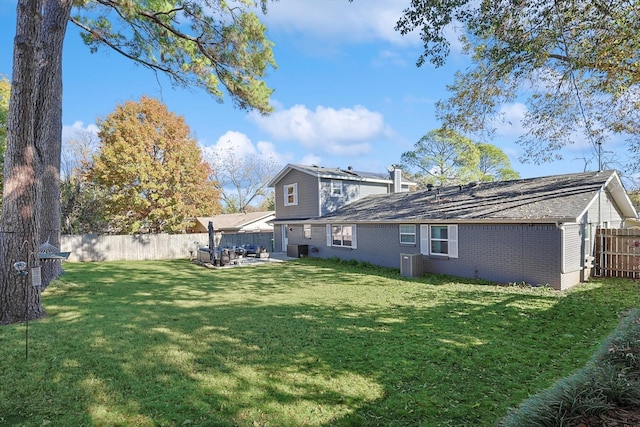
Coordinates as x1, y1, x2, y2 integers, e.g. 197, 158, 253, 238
0, 259, 640, 427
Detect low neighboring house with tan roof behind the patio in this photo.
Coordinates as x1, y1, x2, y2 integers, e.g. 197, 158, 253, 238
191, 211, 275, 250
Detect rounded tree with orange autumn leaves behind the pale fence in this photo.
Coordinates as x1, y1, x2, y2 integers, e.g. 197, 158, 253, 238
89, 96, 220, 233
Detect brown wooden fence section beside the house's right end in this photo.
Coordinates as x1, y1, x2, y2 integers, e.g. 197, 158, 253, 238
595, 228, 640, 279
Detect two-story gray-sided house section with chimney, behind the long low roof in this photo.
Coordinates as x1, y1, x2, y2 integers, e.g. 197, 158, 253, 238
269, 164, 416, 251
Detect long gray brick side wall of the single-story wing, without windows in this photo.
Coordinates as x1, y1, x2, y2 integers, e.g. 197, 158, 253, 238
284, 224, 575, 289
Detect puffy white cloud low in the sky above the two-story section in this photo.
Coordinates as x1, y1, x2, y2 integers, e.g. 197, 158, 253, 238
249, 105, 391, 155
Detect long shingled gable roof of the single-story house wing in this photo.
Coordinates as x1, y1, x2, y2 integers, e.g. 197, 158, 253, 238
315, 171, 637, 223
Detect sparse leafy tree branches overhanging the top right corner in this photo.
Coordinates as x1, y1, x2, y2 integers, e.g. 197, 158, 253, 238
396, 0, 640, 170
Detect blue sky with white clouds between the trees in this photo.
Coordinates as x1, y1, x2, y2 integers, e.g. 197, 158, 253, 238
0, 0, 620, 181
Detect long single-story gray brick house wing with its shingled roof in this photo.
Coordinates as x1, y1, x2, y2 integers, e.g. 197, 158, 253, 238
274, 171, 637, 289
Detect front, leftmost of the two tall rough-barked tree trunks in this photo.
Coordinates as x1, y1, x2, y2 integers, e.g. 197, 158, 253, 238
0, 0, 44, 324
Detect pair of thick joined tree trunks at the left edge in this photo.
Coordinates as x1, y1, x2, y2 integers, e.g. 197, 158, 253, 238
0, 0, 72, 324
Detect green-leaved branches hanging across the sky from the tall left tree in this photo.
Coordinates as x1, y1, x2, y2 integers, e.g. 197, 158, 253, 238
71, 0, 276, 113
